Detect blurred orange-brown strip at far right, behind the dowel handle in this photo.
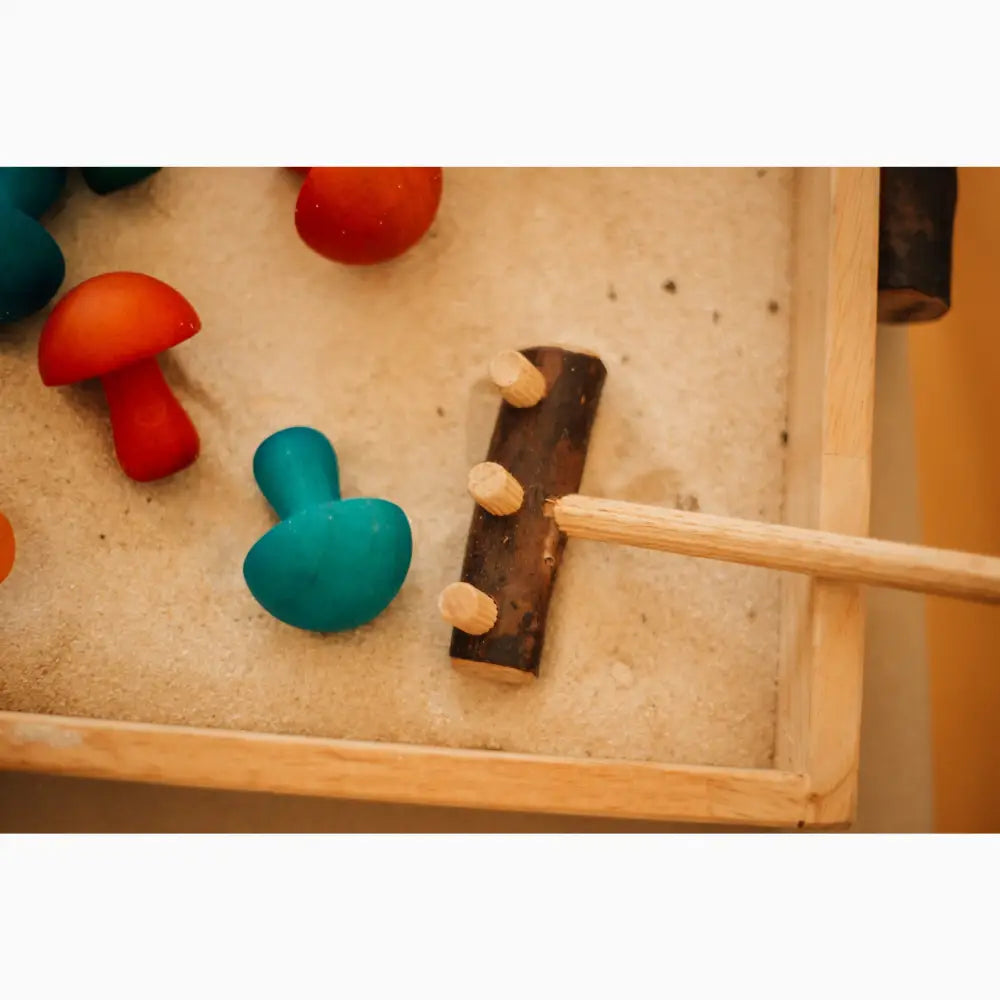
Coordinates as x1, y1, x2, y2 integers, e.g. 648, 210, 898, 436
909, 167, 1000, 833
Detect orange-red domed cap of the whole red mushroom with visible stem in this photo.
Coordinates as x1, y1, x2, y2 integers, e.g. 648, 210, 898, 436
38, 271, 201, 386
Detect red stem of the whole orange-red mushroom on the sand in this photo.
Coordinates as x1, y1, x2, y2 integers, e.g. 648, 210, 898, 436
101, 357, 201, 483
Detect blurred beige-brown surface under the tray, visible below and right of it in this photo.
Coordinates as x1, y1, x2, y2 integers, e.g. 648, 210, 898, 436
0, 327, 933, 832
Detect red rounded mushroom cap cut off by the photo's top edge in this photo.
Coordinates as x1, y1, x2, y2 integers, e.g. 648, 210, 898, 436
293, 167, 442, 264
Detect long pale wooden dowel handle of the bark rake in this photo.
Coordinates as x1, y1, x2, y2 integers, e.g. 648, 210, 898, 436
548, 495, 1000, 603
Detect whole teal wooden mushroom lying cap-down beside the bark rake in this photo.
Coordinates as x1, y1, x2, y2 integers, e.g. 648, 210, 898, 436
243, 427, 413, 632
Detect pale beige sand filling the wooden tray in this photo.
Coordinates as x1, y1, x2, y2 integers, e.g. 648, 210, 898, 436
0, 169, 792, 766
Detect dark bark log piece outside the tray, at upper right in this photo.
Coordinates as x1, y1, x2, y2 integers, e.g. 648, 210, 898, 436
878, 167, 958, 323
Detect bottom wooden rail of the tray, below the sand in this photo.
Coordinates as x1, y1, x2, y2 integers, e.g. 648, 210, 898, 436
0, 712, 817, 829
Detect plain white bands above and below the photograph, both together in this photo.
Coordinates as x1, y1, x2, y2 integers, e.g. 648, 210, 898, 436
0, 0, 1000, 1000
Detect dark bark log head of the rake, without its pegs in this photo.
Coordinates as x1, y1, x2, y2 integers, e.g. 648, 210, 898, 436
450, 347, 607, 683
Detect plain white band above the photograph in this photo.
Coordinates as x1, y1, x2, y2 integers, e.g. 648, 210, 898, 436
7, 0, 1000, 166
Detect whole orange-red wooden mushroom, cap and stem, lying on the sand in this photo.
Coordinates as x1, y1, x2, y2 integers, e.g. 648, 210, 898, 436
38, 271, 201, 482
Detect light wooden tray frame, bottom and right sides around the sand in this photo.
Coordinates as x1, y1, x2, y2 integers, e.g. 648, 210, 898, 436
0, 168, 879, 829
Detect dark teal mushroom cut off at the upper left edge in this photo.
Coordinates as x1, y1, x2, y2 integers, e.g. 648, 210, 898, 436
0, 167, 66, 323
